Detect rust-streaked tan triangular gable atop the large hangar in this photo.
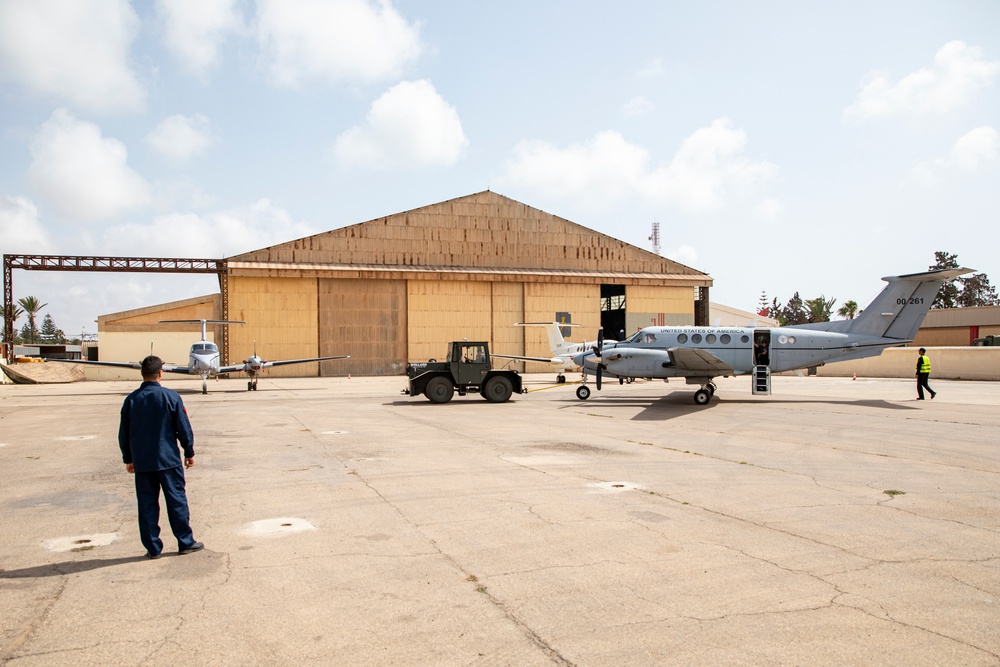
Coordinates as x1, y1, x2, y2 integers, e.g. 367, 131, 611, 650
229, 190, 711, 285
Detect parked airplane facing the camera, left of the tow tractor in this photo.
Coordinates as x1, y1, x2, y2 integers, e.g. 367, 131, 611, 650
49, 320, 350, 394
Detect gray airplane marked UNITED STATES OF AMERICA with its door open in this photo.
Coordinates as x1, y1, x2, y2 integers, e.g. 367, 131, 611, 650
574, 269, 972, 405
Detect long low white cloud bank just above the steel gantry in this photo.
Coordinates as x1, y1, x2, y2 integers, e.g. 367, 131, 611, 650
101, 199, 315, 257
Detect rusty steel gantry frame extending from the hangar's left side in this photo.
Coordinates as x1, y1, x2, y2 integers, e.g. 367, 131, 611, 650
3, 255, 229, 364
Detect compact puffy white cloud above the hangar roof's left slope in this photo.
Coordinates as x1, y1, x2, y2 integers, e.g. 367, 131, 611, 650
333, 80, 469, 168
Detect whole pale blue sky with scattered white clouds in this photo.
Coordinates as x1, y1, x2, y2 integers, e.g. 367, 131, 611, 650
0, 0, 1000, 340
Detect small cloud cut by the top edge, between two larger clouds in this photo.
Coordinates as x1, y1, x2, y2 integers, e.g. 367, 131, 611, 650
156, 0, 243, 76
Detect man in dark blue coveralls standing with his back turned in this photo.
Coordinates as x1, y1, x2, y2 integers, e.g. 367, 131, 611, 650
118, 355, 205, 558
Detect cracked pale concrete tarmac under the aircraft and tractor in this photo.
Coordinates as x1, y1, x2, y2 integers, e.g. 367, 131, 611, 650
0, 375, 1000, 667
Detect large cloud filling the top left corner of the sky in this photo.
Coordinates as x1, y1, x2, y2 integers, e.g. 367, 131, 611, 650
0, 0, 145, 112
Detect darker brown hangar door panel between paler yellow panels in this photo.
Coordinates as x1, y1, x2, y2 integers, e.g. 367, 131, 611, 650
319, 278, 406, 376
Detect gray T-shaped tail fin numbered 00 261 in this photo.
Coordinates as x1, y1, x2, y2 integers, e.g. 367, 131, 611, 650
810, 269, 972, 340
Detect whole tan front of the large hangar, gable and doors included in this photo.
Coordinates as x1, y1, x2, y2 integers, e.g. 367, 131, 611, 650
227, 191, 712, 376
